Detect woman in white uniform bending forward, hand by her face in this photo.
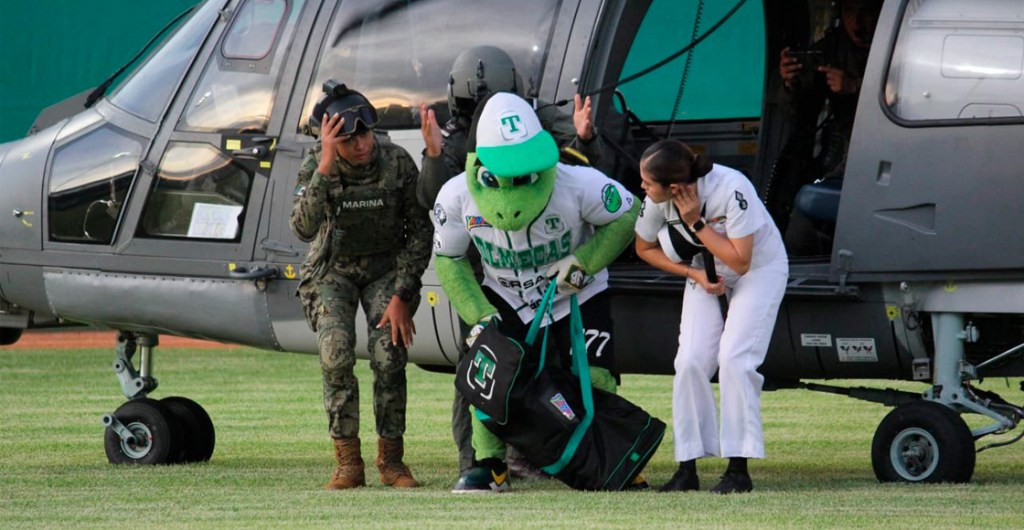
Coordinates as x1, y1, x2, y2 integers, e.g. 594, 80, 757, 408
636, 139, 788, 493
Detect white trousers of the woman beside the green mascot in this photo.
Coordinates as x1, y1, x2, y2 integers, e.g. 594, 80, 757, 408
672, 260, 788, 461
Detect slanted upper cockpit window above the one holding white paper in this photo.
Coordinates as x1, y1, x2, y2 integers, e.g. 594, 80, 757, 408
177, 0, 305, 133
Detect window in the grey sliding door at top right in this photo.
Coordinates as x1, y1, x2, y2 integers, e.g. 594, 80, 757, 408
885, 0, 1024, 122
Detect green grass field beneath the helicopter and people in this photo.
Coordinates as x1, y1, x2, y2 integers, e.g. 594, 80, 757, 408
0, 348, 1024, 529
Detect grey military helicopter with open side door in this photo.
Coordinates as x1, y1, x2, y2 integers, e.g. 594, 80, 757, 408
0, 0, 1024, 482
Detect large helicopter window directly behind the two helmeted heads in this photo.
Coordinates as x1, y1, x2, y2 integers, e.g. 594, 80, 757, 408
296, 0, 561, 131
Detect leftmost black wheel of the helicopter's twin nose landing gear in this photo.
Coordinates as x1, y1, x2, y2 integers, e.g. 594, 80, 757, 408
103, 398, 181, 465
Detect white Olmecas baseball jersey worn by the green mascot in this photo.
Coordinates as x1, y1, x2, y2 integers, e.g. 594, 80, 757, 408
433, 164, 634, 322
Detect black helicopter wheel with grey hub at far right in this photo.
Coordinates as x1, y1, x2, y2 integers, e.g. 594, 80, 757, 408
871, 401, 975, 482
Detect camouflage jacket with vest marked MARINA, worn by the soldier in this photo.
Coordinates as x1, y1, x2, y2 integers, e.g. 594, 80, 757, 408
290, 135, 433, 298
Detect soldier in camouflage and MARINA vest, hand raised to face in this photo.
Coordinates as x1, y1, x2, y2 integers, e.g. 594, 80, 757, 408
291, 81, 432, 489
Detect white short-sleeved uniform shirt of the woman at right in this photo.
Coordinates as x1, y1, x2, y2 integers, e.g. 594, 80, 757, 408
636, 164, 786, 276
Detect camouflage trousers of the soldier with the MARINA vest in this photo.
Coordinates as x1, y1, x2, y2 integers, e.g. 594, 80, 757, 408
316, 258, 419, 438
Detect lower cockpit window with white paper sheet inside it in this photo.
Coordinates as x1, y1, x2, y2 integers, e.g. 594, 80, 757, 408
139, 142, 253, 241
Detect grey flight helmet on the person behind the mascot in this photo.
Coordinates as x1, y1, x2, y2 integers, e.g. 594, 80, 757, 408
447, 46, 522, 117
